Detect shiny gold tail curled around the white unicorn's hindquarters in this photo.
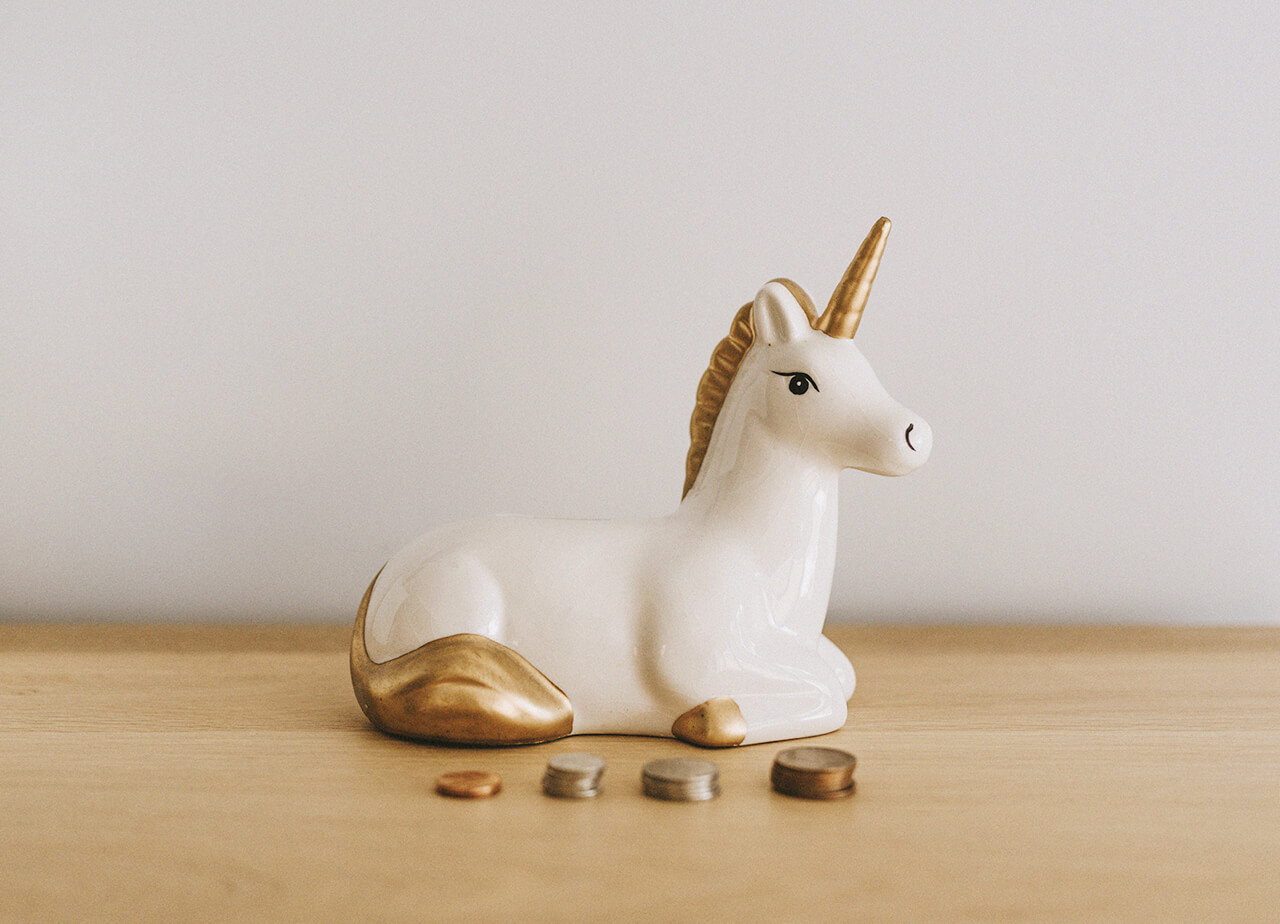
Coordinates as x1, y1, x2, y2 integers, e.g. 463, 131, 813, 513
351, 572, 573, 745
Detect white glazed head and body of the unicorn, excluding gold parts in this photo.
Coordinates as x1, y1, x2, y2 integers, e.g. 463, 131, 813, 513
365, 283, 932, 744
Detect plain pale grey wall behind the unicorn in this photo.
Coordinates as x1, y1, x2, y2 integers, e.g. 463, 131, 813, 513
0, 3, 1280, 623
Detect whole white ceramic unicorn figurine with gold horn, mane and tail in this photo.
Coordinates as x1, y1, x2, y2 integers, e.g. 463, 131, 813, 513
351, 219, 932, 747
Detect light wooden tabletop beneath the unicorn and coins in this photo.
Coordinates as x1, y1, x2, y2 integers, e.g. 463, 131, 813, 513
0, 625, 1280, 921
